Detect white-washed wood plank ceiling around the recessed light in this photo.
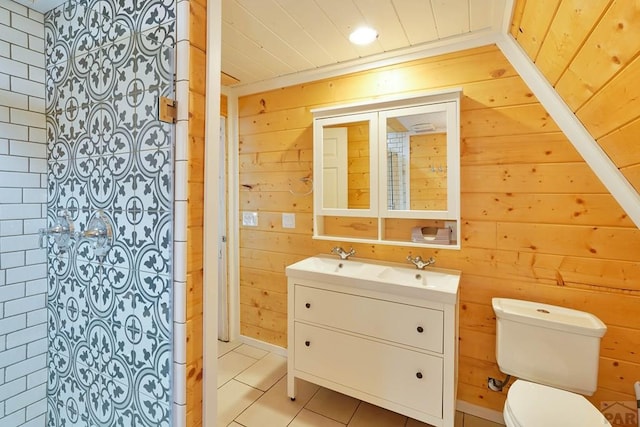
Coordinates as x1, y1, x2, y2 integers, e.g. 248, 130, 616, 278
222, 0, 511, 86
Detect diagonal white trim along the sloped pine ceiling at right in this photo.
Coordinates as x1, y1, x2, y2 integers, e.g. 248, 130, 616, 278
498, 34, 640, 231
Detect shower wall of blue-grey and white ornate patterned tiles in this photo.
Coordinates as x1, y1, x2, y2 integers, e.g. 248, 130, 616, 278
45, 0, 175, 427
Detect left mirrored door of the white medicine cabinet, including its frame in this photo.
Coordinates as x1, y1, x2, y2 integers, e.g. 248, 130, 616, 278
314, 113, 378, 216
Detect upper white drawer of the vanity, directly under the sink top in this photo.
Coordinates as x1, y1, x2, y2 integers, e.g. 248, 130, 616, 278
294, 285, 443, 353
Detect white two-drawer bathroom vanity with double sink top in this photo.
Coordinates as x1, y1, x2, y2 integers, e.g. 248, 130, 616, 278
286, 256, 460, 427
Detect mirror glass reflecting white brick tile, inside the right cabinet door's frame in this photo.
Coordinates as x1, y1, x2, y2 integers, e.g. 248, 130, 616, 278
387, 111, 447, 210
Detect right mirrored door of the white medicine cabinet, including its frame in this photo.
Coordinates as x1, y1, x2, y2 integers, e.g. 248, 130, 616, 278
379, 103, 459, 219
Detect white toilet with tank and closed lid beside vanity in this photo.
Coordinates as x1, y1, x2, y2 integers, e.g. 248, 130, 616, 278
492, 298, 611, 427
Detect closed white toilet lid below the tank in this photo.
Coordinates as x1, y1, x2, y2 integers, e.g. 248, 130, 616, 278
504, 380, 611, 427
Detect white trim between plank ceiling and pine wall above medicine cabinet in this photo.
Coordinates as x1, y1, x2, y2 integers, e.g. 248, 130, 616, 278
230, 29, 501, 96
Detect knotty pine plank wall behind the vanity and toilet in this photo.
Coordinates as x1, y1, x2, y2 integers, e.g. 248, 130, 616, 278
239, 42, 640, 411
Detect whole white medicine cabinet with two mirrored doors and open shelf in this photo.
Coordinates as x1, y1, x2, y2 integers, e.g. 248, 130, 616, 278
312, 89, 461, 249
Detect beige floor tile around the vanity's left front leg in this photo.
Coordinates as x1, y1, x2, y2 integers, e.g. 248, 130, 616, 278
236, 376, 319, 427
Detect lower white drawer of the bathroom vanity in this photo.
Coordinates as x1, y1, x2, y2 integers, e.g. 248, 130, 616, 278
294, 322, 443, 417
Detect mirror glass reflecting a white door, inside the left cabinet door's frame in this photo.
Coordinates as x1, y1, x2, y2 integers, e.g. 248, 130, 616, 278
322, 121, 371, 209
